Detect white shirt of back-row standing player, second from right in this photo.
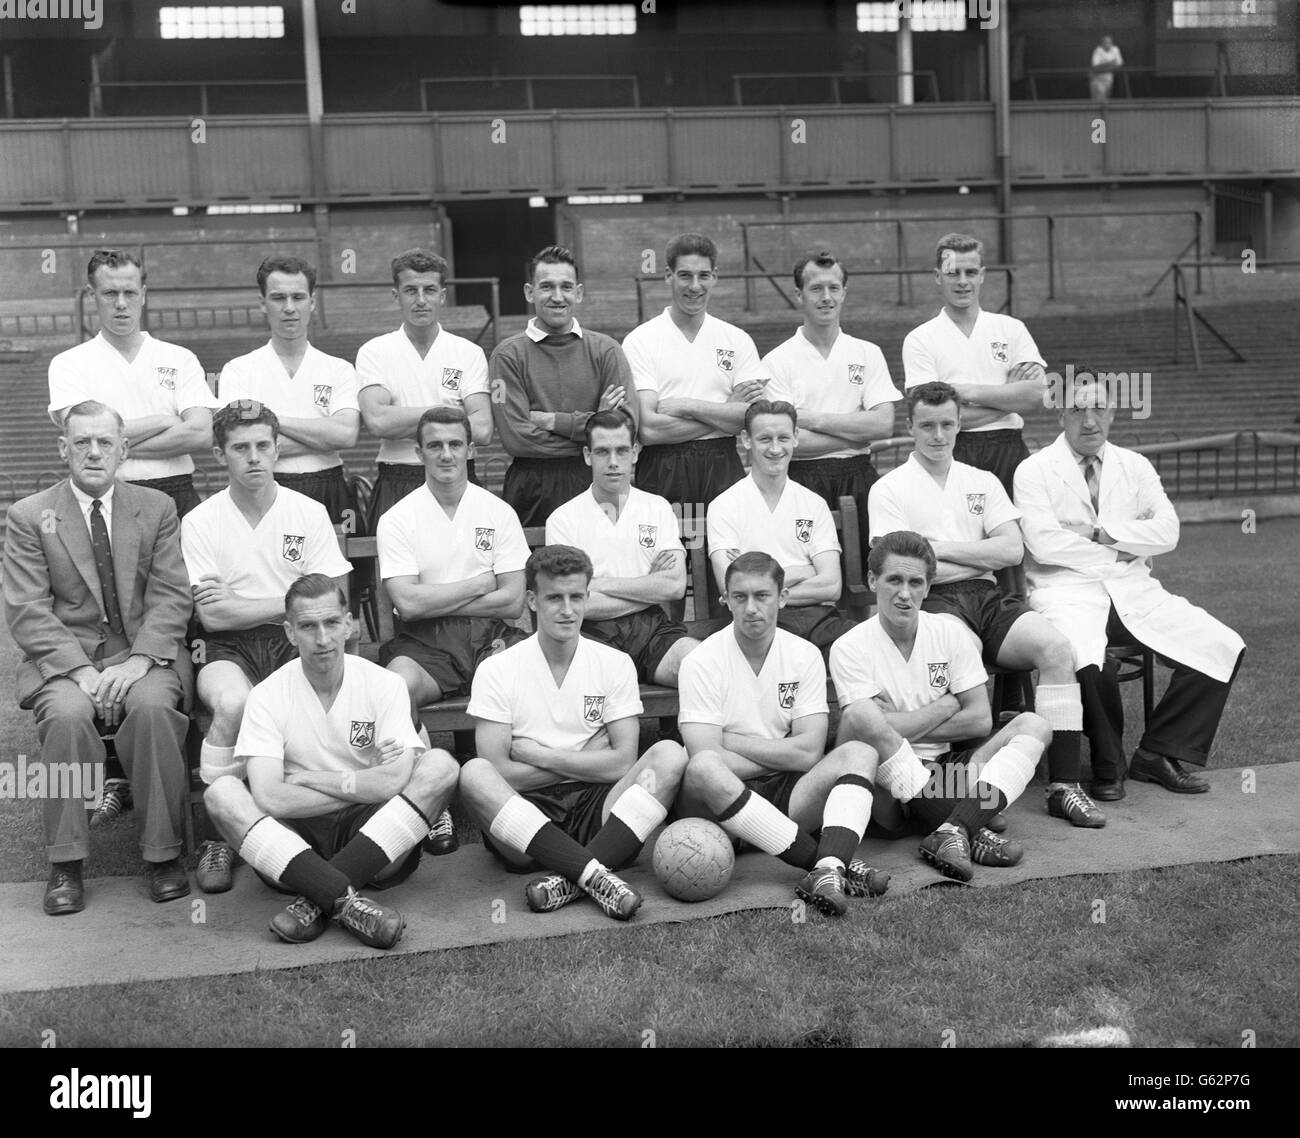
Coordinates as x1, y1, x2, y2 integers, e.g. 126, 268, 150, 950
763, 328, 902, 460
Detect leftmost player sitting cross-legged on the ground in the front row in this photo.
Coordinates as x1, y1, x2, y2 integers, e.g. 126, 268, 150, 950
204, 574, 456, 948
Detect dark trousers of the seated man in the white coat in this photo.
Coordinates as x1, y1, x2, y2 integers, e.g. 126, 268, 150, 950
1078, 605, 1245, 782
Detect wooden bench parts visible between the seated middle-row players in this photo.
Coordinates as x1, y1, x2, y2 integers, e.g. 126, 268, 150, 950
339, 497, 872, 753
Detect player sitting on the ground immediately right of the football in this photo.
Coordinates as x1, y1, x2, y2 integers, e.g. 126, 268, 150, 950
677, 553, 889, 917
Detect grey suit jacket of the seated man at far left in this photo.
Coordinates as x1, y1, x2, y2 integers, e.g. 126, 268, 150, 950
4, 479, 194, 708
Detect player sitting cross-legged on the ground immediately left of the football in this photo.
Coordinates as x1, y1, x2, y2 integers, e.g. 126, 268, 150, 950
460, 545, 686, 921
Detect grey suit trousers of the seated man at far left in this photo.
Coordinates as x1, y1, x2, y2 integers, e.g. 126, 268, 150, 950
33, 667, 190, 861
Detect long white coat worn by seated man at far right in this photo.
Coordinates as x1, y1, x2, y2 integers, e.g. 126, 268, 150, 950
1015, 434, 1245, 683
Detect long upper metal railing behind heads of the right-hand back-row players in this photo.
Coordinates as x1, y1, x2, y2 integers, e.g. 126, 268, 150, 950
740, 208, 1205, 312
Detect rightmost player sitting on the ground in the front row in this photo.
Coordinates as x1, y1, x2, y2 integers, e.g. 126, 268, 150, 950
831, 530, 1052, 882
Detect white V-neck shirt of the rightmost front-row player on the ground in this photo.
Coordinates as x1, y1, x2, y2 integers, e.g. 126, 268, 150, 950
832, 613, 988, 758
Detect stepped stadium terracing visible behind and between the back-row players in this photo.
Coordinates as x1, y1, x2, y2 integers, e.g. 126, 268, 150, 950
0, 300, 1300, 535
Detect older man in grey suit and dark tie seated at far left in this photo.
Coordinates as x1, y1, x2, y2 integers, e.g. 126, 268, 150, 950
4, 401, 192, 916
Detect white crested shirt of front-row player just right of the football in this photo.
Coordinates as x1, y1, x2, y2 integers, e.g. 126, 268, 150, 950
677, 624, 829, 739
